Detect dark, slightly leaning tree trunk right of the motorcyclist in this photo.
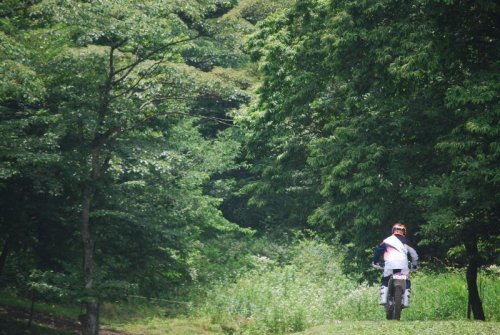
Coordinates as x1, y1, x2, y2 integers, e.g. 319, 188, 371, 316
465, 239, 486, 321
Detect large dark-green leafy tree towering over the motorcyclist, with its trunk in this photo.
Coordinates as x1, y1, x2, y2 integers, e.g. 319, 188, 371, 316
250, 0, 499, 319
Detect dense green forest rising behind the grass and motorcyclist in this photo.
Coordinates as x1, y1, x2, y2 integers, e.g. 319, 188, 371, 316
0, 0, 500, 335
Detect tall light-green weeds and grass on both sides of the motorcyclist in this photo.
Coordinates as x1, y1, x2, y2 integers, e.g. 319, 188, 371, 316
203, 241, 500, 334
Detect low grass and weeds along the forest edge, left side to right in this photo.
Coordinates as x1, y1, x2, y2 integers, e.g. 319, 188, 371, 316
0, 240, 500, 335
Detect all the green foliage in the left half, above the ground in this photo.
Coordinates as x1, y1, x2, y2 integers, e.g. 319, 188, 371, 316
0, 0, 251, 314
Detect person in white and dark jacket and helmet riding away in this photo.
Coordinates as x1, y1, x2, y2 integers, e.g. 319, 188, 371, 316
372, 223, 418, 307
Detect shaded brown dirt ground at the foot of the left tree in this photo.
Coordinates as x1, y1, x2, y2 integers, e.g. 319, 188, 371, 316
0, 305, 129, 335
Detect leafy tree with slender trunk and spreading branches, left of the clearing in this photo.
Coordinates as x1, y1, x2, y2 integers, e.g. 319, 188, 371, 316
1, 0, 254, 334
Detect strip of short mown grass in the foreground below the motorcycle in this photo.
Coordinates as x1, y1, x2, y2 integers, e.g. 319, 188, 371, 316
295, 321, 500, 335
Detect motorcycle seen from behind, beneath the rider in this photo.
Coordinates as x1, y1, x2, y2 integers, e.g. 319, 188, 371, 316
373, 265, 410, 320
